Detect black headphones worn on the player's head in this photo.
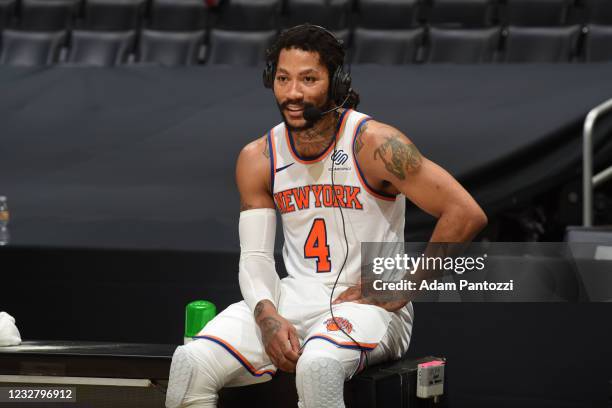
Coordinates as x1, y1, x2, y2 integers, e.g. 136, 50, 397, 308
263, 24, 351, 104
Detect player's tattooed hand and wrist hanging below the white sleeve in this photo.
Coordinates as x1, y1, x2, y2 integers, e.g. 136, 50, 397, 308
255, 300, 300, 373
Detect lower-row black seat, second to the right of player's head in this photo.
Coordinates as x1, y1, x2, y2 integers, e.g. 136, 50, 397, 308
427, 28, 501, 64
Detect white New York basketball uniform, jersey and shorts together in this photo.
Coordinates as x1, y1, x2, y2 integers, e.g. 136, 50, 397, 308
189, 110, 414, 386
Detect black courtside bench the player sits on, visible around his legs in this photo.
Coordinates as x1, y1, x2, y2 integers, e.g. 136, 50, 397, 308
0, 341, 446, 408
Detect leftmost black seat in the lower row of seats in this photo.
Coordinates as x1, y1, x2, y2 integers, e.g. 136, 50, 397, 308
0, 30, 66, 66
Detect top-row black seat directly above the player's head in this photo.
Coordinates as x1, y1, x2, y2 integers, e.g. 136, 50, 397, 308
285, 0, 351, 30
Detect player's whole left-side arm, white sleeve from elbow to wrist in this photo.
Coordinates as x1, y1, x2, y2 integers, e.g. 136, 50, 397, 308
236, 137, 300, 372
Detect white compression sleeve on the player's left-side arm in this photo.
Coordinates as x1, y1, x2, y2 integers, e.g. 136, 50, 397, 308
238, 208, 280, 310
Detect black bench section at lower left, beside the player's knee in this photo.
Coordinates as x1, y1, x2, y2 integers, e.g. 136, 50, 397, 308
0, 341, 176, 408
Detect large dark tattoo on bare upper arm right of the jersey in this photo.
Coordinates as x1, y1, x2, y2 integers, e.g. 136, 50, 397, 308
374, 134, 423, 180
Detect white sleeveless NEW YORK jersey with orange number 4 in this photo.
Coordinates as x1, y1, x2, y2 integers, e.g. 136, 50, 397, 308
267, 110, 406, 286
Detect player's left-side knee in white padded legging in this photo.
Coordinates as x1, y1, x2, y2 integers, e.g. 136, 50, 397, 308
166, 340, 236, 408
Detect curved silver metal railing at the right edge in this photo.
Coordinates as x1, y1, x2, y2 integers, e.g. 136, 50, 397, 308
582, 99, 612, 227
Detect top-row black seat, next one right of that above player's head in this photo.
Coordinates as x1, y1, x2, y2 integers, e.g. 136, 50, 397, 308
357, 0, 419, 30
